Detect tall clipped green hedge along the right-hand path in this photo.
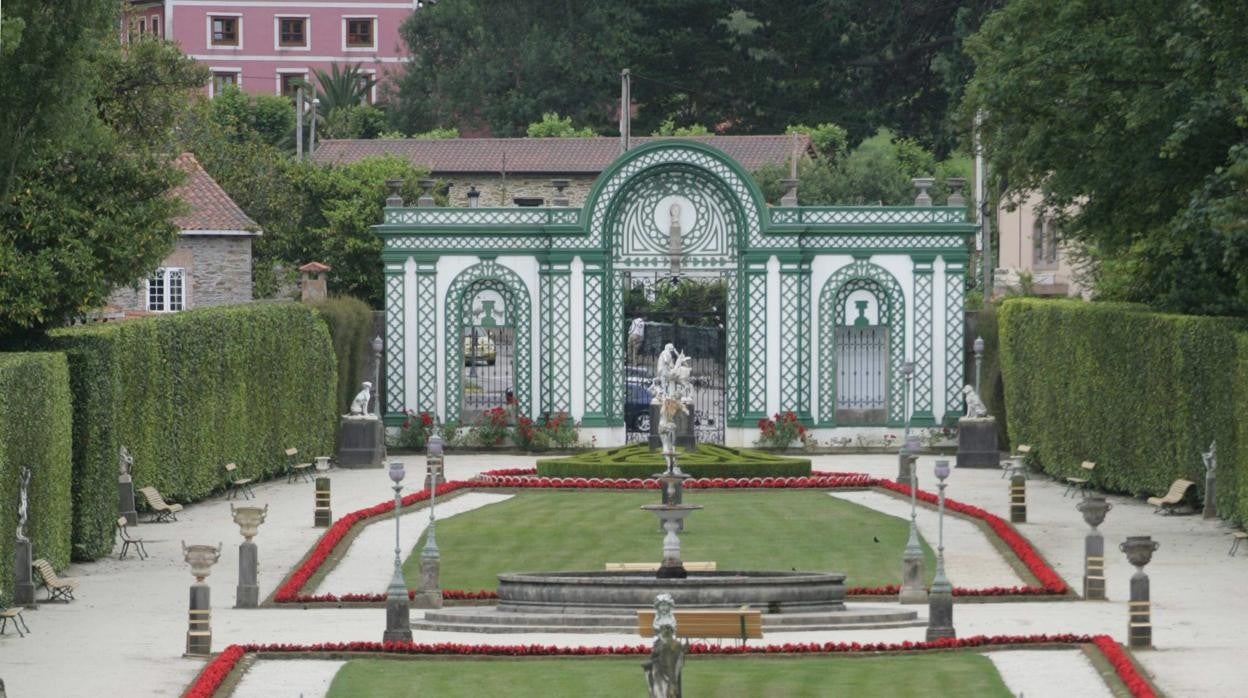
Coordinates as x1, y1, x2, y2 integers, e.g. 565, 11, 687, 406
1000, 298, 1248, 521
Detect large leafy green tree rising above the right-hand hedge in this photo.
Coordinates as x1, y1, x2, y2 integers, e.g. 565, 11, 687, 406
962, 0, 1248, 315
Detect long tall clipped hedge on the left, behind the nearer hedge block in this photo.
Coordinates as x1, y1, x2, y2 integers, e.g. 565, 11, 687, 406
52, 303, 337, 558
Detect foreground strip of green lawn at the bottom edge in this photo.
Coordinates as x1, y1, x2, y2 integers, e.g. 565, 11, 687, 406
329, 652, 1011, 698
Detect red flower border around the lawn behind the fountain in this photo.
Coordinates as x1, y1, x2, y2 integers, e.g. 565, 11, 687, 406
272, 468, 1070, 604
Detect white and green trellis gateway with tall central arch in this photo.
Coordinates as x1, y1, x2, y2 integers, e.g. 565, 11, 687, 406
374, 140, 973, 446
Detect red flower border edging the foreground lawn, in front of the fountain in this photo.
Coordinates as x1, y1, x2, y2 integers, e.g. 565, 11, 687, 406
183, 634, 1156, 698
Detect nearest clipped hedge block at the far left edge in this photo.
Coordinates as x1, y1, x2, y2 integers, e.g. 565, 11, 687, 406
0, 352, 72, 599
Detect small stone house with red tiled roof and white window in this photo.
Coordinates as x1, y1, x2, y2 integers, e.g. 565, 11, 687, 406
109, 152, 261, 313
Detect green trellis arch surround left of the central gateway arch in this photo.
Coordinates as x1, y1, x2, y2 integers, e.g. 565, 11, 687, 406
444, 260, 533, 420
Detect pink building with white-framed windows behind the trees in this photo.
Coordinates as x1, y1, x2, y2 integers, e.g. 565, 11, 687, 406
126, 0, 424, 100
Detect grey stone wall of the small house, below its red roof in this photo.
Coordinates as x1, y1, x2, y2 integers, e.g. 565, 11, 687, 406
109, 235, 251, 310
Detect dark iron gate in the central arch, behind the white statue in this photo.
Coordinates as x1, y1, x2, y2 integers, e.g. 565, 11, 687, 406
623, 276, 728, 445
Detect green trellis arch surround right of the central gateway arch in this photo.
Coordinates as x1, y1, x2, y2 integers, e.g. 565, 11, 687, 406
819, 260, 906, 427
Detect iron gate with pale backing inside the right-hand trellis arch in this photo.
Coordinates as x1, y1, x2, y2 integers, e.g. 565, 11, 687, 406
836, 325, 889, 425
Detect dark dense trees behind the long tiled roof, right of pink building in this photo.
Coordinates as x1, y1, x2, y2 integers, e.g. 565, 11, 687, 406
393, 0, 1002, 154
